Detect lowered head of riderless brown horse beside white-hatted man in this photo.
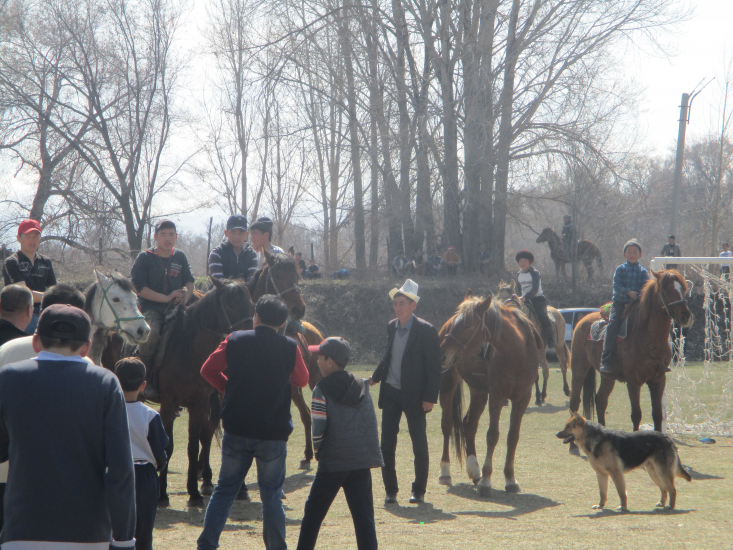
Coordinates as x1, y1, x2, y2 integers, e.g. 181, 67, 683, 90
440, 290, 492, 370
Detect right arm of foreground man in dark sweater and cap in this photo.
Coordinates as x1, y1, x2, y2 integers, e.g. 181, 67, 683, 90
104, 379, 135, 547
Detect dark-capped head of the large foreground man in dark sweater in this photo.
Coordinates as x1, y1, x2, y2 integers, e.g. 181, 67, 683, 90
33, 304, 92, 355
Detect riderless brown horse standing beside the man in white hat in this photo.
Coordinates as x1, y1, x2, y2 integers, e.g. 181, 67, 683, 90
440, 291, 542, 496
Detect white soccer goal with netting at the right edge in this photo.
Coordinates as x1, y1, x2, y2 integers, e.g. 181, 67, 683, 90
651, 258, 733, 437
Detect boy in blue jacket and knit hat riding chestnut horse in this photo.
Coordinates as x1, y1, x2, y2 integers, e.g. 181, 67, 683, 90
600, 239, 649, 376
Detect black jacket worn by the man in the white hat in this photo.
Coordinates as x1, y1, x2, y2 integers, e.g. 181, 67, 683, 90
372, 317, 441, 410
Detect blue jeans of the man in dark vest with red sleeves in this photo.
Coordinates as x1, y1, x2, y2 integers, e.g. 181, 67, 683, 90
198, 432, 288, 550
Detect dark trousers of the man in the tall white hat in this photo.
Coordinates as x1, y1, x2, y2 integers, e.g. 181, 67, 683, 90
382, 382, 430, 495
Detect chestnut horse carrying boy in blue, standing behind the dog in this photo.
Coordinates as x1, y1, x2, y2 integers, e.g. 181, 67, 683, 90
570, 269, 693, 452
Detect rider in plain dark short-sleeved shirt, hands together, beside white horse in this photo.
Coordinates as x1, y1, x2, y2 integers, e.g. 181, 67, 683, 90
132, 219, 194, 398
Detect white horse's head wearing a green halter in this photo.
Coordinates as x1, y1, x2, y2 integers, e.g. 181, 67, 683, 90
84, 269, 150, 366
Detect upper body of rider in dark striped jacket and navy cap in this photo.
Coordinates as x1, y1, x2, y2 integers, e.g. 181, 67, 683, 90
209, 214, 257, 281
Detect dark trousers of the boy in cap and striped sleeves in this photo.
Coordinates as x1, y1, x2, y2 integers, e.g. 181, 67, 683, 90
297, 468, 377, 550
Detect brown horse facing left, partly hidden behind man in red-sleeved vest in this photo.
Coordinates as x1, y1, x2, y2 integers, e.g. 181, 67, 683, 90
248, 250, 323, 470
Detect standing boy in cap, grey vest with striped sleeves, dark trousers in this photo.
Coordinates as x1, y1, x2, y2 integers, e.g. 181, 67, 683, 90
298, 337, 383, 550
